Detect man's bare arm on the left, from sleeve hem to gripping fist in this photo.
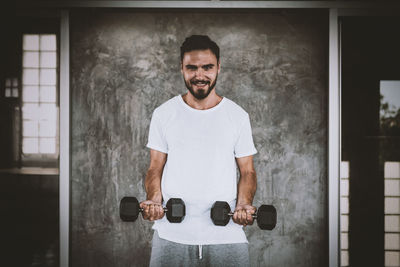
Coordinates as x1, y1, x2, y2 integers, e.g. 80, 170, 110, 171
140, 149, 167, 221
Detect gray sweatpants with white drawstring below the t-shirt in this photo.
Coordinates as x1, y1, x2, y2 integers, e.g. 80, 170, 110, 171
150, 231, 250, 267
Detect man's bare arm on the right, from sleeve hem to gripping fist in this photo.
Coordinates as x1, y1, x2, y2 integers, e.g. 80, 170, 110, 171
233, 156, 257, 225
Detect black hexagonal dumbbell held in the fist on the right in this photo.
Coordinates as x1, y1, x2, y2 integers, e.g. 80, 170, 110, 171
210, 201, 276, 230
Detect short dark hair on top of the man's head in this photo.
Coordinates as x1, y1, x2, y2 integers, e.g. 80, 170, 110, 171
181, 35, 219, 62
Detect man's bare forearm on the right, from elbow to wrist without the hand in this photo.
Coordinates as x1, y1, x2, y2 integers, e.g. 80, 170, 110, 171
237, 172, 257, 205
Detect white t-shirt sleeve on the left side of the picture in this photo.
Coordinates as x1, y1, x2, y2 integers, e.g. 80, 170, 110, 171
146, 109, 168, 154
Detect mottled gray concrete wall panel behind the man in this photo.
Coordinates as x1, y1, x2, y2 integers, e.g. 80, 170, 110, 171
71, 9, 328, 267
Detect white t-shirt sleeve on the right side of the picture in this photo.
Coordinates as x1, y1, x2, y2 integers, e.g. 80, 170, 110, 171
235, 114, 257, 158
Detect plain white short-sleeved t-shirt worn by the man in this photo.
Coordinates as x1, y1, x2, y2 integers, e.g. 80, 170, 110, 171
147, 95, 257, 245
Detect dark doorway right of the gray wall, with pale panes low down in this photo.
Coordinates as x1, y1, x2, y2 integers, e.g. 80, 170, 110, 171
341, 17, 400, 266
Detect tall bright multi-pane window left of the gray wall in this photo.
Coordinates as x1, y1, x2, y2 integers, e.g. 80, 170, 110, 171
22, 34, 58, 160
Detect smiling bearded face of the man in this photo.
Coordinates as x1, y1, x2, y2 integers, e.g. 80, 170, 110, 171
181, 49, 220, 100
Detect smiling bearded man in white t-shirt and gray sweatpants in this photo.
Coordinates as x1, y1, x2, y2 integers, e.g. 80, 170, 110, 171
140, 35, 257, 266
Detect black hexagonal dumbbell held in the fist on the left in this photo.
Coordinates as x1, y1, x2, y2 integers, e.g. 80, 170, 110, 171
119, 197, 186, 223
